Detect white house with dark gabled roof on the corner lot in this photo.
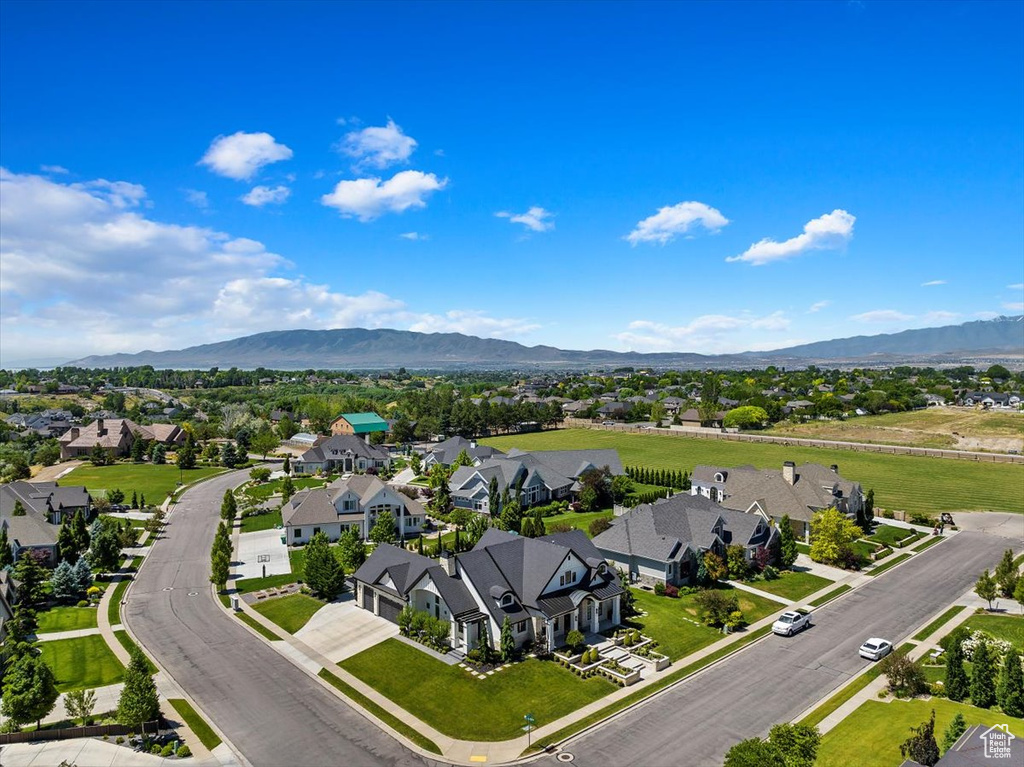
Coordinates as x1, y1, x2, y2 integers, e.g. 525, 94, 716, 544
352, 527, 623, 653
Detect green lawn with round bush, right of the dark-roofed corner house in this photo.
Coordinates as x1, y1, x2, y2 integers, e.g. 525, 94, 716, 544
629, 586, 782, 661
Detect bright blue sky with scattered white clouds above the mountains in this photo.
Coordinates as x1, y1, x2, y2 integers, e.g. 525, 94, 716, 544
0, 0, 1024, 365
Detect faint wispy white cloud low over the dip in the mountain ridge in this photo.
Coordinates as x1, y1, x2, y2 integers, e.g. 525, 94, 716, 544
612, 311, 791, 353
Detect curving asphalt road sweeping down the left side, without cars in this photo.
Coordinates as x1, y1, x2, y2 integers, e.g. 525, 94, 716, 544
124, 472, 435, 767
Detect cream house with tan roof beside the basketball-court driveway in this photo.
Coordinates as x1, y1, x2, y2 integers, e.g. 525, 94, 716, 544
281, 474, 426, 546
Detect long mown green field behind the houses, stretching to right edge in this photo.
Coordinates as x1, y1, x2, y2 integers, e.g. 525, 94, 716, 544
481, 429, 1024, 514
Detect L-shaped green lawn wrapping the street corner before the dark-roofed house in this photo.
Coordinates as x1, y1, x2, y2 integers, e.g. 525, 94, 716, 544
340, 639, 617, 741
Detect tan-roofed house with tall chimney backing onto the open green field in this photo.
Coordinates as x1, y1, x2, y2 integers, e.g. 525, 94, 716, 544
690, 461, 864, 541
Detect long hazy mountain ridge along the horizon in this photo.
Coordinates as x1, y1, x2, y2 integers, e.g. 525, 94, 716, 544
68, 316, 1024, 370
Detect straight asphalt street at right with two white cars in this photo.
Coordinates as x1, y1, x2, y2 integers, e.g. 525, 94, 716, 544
541, 532, 1022, 767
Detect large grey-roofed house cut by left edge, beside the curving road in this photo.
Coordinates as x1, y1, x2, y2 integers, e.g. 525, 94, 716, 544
0, 480, 92, 563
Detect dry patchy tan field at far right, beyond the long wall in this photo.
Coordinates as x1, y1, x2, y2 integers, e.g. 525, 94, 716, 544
764, 408, 1024, 452
